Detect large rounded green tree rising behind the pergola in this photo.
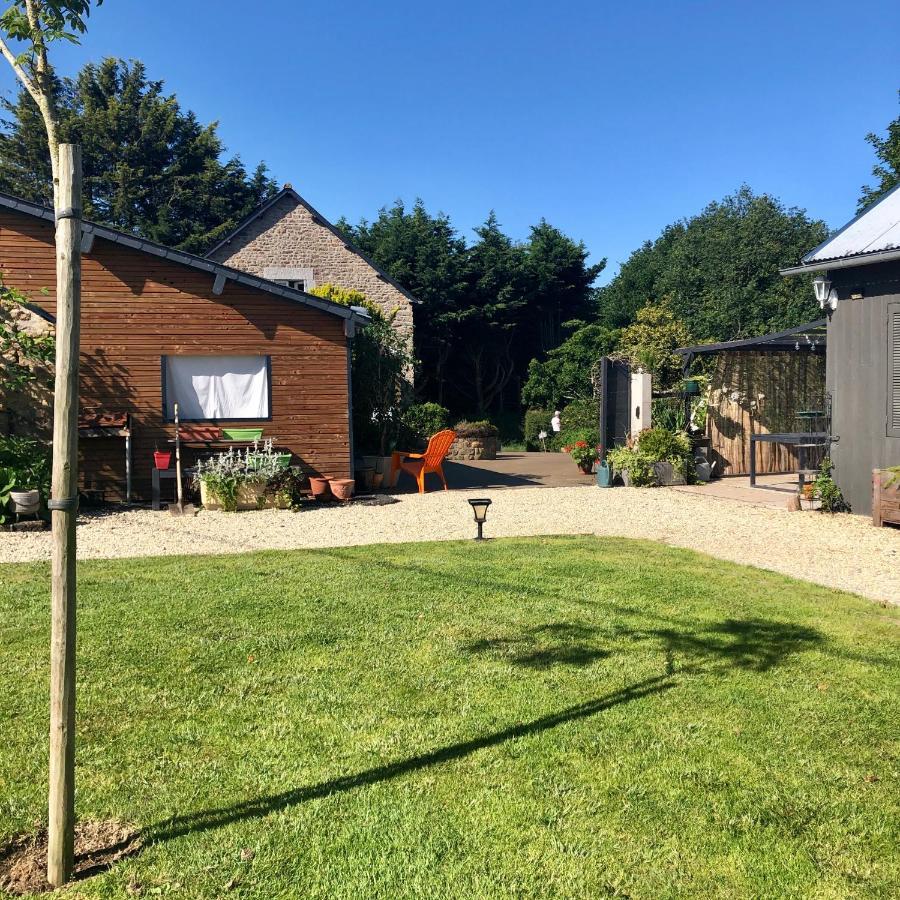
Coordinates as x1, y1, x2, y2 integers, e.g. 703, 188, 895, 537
597, 186, 827, 340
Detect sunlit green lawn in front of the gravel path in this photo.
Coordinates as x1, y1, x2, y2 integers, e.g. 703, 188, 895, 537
0, 536, 900, 900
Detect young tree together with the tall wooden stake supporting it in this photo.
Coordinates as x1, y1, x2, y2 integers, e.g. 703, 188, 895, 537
0, 0, 102, 887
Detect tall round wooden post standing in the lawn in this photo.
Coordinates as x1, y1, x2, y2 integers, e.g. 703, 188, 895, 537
47, 144, 81, 887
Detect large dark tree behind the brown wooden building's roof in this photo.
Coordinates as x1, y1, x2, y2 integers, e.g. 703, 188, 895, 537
0, 58, 276, 252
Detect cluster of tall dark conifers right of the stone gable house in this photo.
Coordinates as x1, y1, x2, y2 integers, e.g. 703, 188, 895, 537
339, 200, 603, 415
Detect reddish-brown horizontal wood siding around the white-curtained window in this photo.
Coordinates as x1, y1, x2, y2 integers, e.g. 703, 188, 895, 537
0, 211, 350, 506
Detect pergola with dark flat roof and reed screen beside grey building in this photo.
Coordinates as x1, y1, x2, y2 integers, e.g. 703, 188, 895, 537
680, 319, 829, 476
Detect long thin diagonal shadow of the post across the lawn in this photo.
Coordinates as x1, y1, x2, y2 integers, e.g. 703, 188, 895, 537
143, 675, 674, 843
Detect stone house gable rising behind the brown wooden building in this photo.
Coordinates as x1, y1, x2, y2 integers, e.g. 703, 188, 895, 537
207, 184, 418, 350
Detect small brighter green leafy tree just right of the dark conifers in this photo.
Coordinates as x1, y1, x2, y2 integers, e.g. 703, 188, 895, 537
522, 323, 619, 409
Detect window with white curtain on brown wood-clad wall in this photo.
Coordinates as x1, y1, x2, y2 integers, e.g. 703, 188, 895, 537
162, 356, 272, 422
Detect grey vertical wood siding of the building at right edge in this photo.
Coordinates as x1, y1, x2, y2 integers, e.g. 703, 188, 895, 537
826, 263, 900, 514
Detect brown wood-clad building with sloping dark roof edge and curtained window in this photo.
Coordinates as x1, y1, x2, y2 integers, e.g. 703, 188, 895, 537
0, 194, 368, 500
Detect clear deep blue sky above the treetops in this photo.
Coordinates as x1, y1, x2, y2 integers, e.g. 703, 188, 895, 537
0, 0, 900, 281
